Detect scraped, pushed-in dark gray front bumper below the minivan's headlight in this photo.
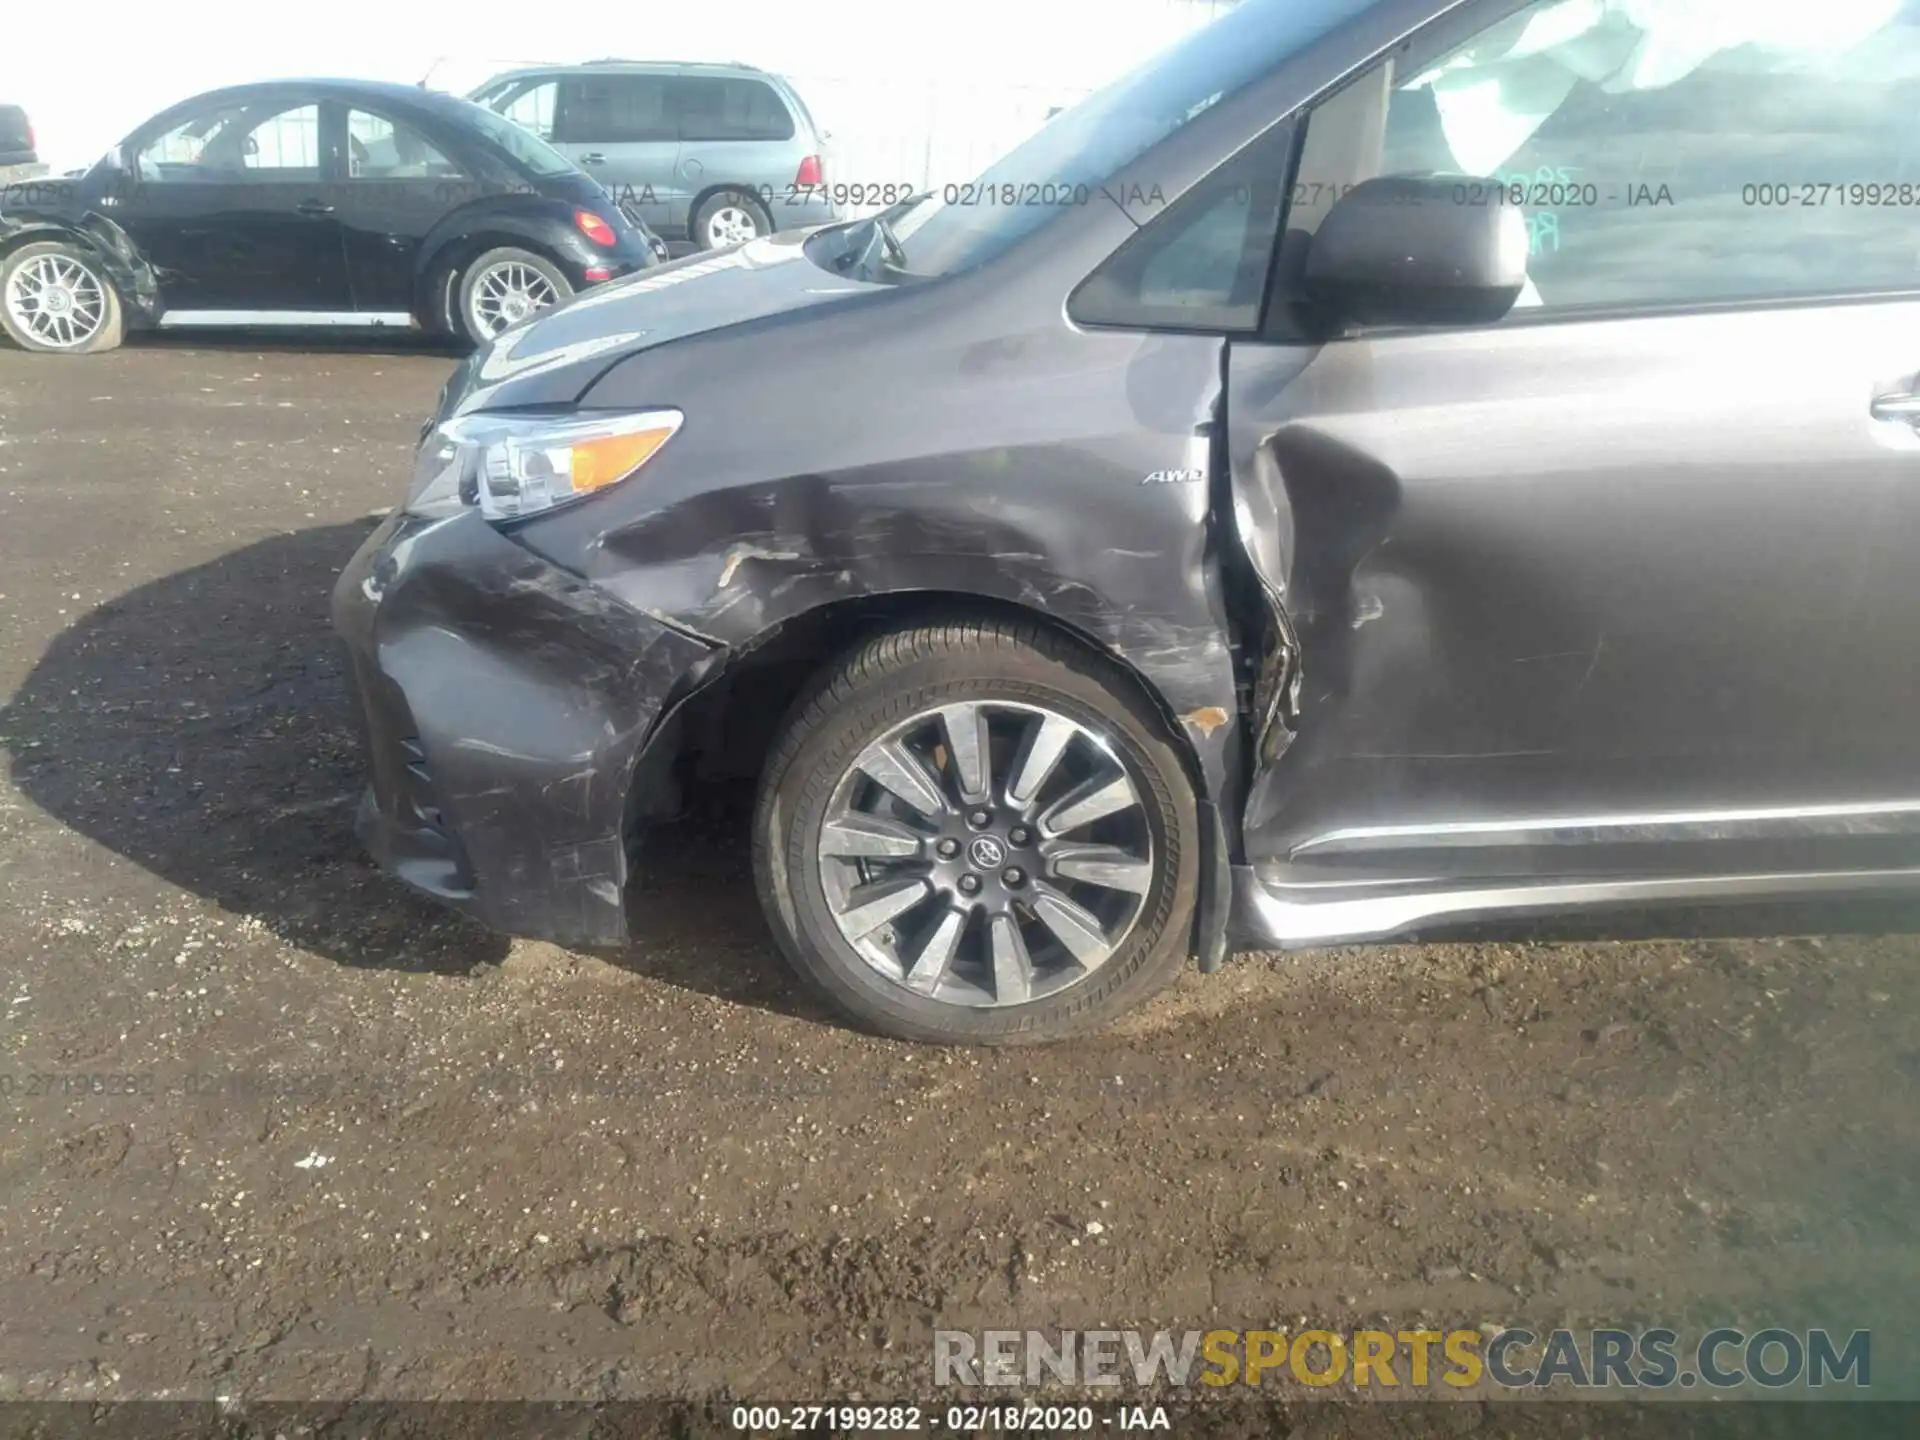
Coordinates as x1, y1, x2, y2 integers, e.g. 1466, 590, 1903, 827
334, 513, 718, 945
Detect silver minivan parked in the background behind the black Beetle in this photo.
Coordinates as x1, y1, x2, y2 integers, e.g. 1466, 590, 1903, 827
472, 60, 837, 250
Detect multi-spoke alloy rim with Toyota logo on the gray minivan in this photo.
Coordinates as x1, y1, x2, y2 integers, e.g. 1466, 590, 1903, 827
816, 701, 1154, 1008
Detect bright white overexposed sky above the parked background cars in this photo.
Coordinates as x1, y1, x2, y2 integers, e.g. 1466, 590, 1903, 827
0, 0, 1215, 179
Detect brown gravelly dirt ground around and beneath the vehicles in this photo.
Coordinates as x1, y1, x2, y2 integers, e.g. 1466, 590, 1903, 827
0, 338, 1920, 1436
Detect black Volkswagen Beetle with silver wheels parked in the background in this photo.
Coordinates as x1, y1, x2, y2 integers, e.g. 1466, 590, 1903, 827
0, 81, 666, 353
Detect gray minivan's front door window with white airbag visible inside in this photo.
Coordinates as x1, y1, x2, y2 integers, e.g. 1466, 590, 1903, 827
1288, 0, 1920, 311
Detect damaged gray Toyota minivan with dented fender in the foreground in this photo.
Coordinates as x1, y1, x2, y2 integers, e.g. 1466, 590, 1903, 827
334, 0, 1920, 1043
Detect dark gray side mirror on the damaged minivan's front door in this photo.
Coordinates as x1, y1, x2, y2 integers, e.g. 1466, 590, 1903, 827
1302, 175, 1528, 324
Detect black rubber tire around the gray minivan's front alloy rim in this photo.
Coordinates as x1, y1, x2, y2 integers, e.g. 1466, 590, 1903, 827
753, 620, 1202, 1044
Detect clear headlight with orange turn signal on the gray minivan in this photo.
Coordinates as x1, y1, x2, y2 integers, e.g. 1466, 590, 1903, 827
407, 411, 685, 520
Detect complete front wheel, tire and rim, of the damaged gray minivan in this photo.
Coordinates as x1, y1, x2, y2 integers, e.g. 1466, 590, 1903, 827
753, 611, 1206, 1044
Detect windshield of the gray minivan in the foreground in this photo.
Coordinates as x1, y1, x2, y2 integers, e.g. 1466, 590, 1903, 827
893, 0, 1373, 276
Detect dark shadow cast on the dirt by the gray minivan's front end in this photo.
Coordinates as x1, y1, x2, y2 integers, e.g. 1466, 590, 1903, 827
0, 520, 812, 1012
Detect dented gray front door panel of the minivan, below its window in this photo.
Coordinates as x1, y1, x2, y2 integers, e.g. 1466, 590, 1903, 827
1227, 303, 1920, 887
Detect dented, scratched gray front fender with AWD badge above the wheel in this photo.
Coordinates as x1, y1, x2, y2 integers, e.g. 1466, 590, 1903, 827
516, 286, 1242, 829
